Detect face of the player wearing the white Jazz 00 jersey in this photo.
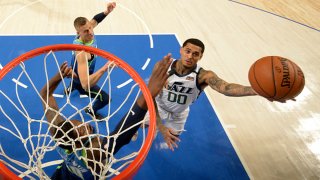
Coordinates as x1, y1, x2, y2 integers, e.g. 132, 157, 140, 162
180, 43, 202, 68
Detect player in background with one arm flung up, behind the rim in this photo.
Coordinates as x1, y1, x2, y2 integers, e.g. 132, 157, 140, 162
67, 2, 116, 119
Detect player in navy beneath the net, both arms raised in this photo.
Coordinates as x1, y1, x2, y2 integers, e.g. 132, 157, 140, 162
40, 54, 172, 180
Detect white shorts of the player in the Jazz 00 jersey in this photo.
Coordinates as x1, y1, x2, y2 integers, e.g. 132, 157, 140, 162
145, 106, 189, 135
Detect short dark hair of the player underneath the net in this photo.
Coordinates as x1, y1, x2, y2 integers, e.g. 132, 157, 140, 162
53, 121, 77, 152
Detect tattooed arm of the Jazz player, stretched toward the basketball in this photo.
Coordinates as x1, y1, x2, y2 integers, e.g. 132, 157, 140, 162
199, 69, 257, 96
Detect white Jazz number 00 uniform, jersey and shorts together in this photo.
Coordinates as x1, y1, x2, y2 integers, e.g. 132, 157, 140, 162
151, 60, 202, 138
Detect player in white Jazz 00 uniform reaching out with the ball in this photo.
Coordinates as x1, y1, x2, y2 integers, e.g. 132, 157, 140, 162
140, 39, 257, 151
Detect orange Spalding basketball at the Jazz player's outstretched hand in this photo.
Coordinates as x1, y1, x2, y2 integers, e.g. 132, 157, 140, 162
248, 56, 305, 101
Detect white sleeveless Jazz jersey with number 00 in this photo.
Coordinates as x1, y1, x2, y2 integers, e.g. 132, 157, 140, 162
156, 61, 202, 113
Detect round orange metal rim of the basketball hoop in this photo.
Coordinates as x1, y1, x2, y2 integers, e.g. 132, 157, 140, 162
0, 44, 156, 179
